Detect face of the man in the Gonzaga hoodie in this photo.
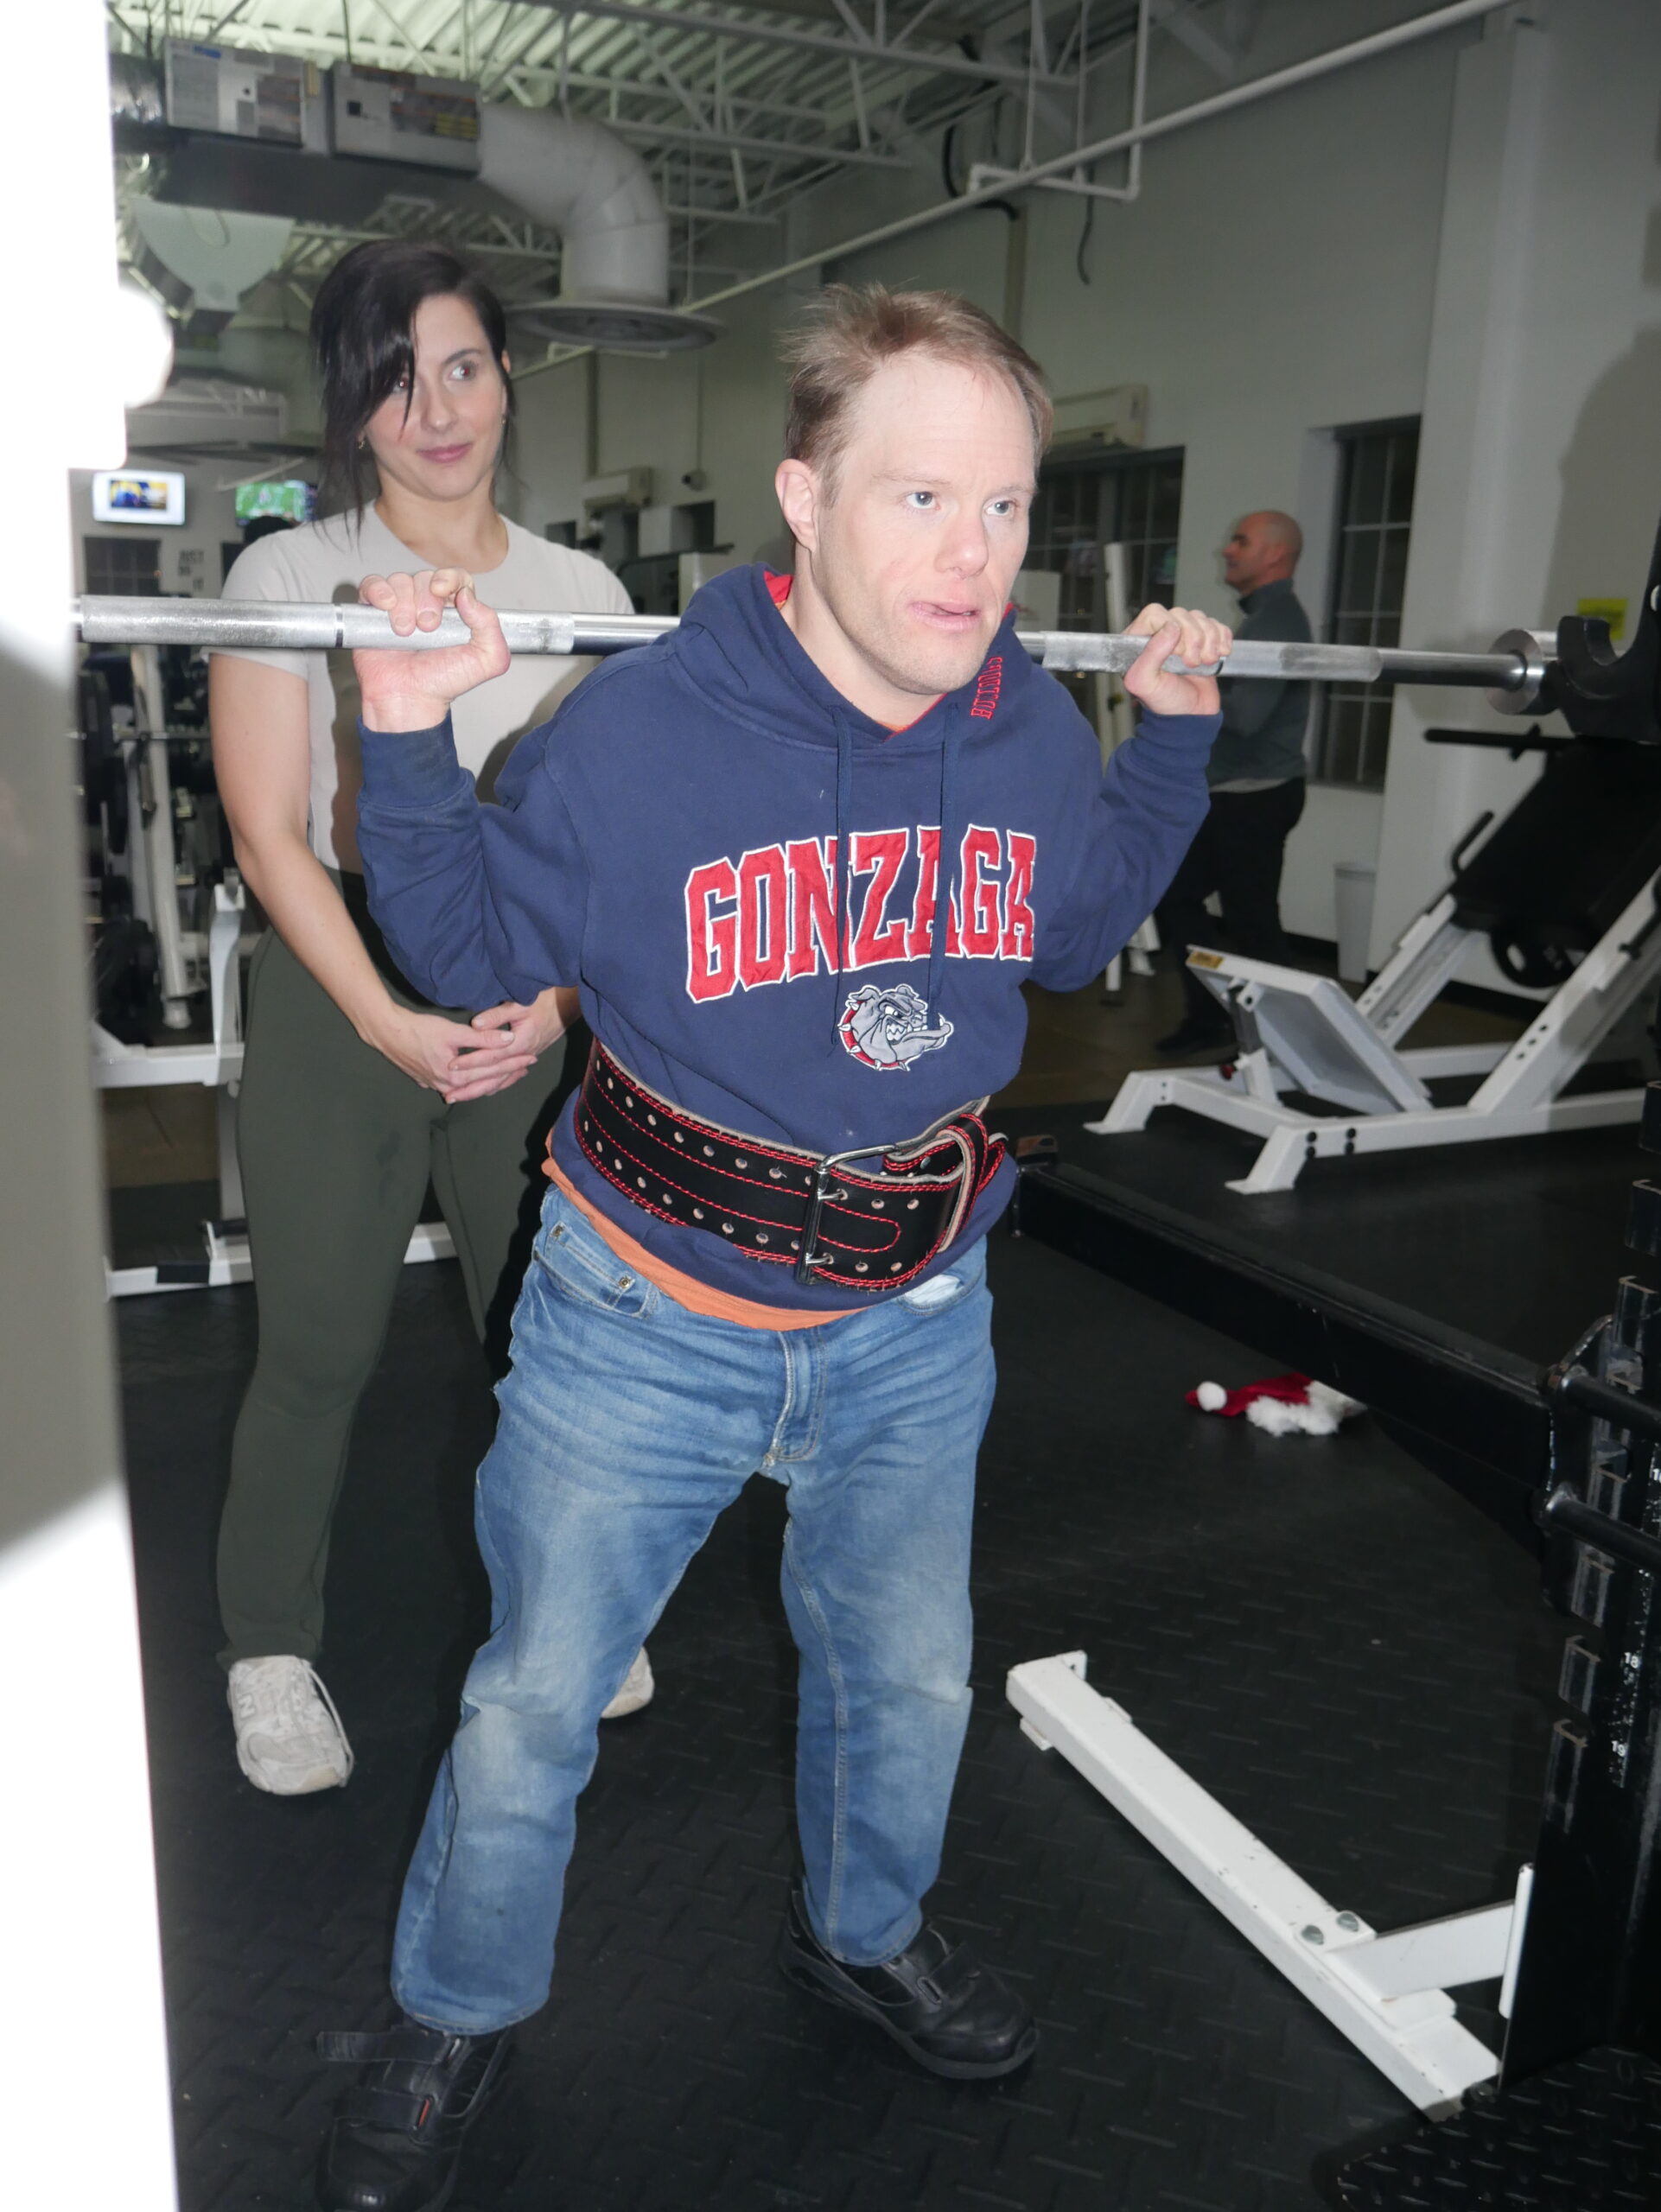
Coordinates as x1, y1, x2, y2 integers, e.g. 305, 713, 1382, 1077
780, 352, 1035, 699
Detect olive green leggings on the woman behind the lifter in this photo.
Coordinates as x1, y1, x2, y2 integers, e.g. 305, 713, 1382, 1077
219, 931, 564, 1666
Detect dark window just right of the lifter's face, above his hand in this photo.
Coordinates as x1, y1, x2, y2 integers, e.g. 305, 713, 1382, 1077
1026, 449, 1183, 631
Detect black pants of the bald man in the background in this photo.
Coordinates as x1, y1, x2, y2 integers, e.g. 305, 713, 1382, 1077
1156, 777, 1302, 1027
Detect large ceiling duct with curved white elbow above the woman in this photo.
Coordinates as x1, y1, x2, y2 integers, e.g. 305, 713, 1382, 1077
111, 40, 719, 352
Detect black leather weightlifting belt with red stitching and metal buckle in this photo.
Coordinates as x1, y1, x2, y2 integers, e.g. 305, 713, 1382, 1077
575, 1044, 1004, 1289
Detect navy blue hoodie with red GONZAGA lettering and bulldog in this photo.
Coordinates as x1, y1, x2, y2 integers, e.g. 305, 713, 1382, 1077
359, 569, 1217, 1310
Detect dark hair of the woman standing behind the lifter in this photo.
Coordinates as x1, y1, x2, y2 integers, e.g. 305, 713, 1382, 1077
312, 238, 513, 513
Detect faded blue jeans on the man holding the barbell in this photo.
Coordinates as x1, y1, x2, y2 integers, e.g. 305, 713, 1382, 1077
394, 1190, 993, 2035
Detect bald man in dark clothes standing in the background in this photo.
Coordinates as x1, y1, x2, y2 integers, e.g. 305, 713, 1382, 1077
1159, 511, 1309, 1058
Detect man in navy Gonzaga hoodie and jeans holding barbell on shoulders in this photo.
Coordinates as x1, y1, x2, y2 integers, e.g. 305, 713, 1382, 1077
305, 289, 1230, 2212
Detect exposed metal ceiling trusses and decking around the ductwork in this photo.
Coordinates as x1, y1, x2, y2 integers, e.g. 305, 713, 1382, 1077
108, 0, 1261, 322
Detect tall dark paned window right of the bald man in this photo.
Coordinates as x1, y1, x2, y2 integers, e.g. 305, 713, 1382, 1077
1312, 420, 1417, 790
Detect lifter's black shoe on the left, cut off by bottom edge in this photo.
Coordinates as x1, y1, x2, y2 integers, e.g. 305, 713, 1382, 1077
316, 2019, 509, 2212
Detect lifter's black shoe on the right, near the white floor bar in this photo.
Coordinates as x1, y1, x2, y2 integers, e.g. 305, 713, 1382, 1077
779, 1896, 1037, 2082
